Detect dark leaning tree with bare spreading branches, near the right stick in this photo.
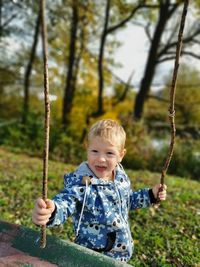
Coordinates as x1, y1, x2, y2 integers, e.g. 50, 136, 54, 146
133, 0, 200, 120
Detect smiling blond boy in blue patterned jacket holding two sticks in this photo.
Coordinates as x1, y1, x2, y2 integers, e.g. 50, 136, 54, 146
32, 119, 166, 261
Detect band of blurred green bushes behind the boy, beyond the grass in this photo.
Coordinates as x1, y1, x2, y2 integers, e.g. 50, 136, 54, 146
0, 113, 200, 180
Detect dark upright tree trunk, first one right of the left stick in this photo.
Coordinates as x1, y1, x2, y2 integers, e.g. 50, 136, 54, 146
62, 1, 79, 127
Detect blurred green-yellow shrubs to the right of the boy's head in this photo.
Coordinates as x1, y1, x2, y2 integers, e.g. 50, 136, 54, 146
123, 118, 200, 180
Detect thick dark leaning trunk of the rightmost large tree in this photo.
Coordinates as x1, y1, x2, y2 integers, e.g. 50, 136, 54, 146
134, 0, 177, 120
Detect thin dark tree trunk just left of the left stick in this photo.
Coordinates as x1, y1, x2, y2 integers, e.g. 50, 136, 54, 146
22, 11, 41, 124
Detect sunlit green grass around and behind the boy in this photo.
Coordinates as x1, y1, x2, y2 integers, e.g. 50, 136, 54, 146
0, 148, 200, 267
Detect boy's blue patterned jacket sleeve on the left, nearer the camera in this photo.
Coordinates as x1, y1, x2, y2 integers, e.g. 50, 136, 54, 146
47, 174, 85, 227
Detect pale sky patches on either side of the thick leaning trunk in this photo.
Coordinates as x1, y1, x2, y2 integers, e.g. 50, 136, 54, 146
114, 24, 174, 90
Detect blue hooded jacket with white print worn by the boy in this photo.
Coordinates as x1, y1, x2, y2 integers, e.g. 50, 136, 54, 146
48, 162, 154, 261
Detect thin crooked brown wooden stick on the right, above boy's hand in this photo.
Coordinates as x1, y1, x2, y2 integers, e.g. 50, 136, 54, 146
160, 0, 189, 191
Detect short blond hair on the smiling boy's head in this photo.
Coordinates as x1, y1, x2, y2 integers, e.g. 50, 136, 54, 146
88, 119, 126, 151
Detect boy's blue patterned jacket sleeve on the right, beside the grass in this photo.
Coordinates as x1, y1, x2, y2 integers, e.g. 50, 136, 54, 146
130, 188, 152, 210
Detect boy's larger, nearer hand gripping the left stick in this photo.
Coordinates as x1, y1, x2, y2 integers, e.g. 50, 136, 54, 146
32, 198, 55, 225
